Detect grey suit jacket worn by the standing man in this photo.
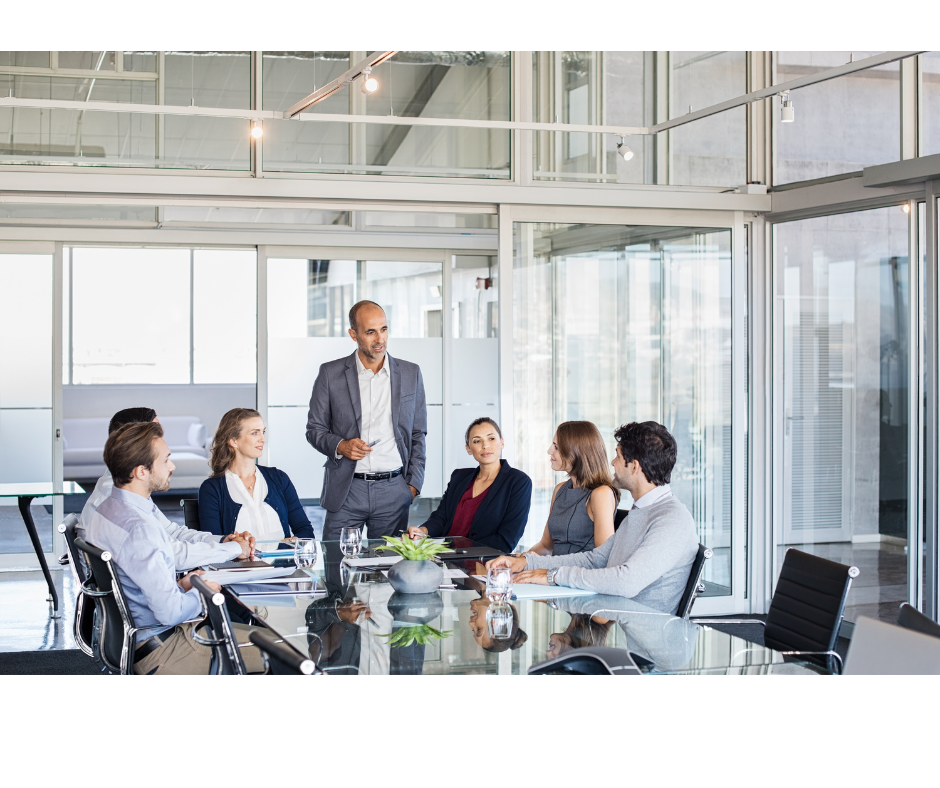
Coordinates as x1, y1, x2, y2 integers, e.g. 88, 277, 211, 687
307, 352, 428, 512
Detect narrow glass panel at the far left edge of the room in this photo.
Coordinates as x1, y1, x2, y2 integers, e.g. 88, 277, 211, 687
0, 252, 54, 553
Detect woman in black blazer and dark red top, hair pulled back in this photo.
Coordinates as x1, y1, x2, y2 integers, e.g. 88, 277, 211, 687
408, 416, 532, 553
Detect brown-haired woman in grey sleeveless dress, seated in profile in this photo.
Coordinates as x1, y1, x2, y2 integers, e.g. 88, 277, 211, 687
527, 421, 620, 555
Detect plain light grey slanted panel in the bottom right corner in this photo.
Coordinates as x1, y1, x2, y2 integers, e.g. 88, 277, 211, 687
843, 616, 940, 676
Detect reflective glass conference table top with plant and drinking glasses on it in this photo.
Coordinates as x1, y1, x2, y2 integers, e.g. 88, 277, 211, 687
226, 539, 826, 675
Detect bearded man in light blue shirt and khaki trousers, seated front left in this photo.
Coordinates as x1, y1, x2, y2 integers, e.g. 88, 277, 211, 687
85, 422, 263, 675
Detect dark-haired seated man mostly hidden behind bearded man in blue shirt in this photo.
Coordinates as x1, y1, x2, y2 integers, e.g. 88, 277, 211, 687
75, 408, 254, 572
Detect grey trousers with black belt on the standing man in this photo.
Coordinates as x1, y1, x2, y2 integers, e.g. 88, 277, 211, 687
323, 474, 412, 541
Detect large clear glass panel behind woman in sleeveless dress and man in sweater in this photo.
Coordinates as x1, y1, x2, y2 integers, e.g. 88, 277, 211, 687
513, 223, 732, 594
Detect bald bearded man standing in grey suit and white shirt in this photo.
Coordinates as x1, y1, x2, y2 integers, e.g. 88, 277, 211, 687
307, 301, 428, 540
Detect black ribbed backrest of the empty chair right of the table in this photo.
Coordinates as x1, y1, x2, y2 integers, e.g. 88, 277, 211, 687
764, 548, 858, 652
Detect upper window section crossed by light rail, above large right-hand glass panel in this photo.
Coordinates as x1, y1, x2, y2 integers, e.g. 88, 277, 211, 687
532, 50, 746, 186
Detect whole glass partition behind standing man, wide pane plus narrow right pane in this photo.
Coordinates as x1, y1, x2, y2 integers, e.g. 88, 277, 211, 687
259, 247, 500, 522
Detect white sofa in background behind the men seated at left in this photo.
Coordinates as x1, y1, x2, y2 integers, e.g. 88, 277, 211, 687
62, 416, 211, 489
